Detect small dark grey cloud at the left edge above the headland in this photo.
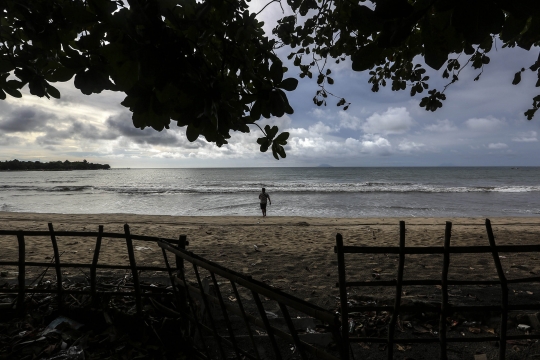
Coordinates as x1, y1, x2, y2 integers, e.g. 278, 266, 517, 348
0, 108, 55, 133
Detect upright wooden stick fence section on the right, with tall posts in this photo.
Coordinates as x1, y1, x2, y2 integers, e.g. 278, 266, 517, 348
334, 219, 540, 360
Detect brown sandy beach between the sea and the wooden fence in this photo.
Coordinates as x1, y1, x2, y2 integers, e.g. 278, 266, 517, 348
0, 212, 540, 309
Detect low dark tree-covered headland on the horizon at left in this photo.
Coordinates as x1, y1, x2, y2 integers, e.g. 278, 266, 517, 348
0, 159, 111, 171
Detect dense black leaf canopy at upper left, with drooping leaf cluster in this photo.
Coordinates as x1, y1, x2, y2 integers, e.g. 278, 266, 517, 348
0, 0, 298, 159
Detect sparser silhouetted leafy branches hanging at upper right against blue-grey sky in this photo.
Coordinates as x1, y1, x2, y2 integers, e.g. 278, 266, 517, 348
273, 0, 540, 120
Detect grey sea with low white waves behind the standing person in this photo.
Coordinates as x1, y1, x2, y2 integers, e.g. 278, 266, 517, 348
0, 167, 540, 218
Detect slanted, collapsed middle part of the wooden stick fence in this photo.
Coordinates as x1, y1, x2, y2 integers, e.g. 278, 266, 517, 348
158, 241, 346, 360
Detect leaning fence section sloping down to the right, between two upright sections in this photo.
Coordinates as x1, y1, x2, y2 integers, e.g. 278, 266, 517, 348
158, 241, 346, 360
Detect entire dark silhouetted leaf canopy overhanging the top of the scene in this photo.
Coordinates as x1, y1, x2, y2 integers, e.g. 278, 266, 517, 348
0, 0, 540, 159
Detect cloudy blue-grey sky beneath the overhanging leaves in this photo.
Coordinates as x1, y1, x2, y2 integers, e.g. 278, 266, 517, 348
0, 0, 540, 168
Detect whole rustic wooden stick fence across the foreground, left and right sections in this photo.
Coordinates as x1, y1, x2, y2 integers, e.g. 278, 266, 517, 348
0, 220, 540, 360
